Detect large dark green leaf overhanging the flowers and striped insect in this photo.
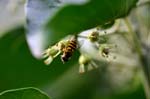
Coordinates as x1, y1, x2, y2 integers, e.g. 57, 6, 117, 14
46, 0, 138, 44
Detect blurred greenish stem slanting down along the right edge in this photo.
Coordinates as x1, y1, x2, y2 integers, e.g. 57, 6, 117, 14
124, 18, 150, 99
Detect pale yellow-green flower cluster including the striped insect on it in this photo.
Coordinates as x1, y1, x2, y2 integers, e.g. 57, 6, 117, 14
43, 29, 115, 73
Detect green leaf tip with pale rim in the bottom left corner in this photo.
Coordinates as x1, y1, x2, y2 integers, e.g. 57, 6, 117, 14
0, 88, 50, 99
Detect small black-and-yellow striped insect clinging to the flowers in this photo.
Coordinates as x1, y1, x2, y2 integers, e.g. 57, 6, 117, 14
61, 36, 77, 63
